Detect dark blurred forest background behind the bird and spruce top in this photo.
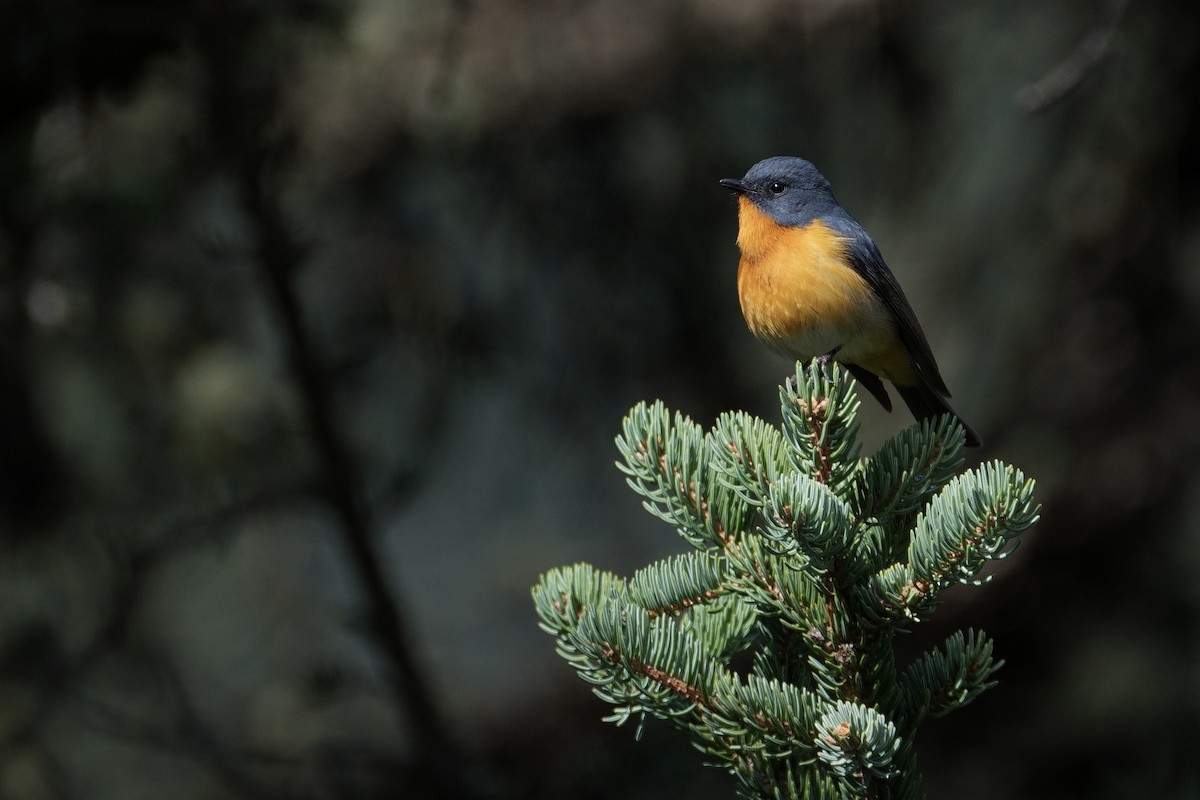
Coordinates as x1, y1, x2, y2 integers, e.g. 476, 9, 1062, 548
0, 0, 1200, 800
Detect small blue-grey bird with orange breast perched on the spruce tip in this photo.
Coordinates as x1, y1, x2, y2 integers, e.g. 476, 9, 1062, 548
720, 156, 980, 446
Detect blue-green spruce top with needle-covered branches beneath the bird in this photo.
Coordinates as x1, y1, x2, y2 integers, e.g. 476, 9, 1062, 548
533, 363, 1038, 800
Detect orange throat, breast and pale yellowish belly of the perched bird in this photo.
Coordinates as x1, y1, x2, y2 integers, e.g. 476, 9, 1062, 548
738, 197, 908, 378
